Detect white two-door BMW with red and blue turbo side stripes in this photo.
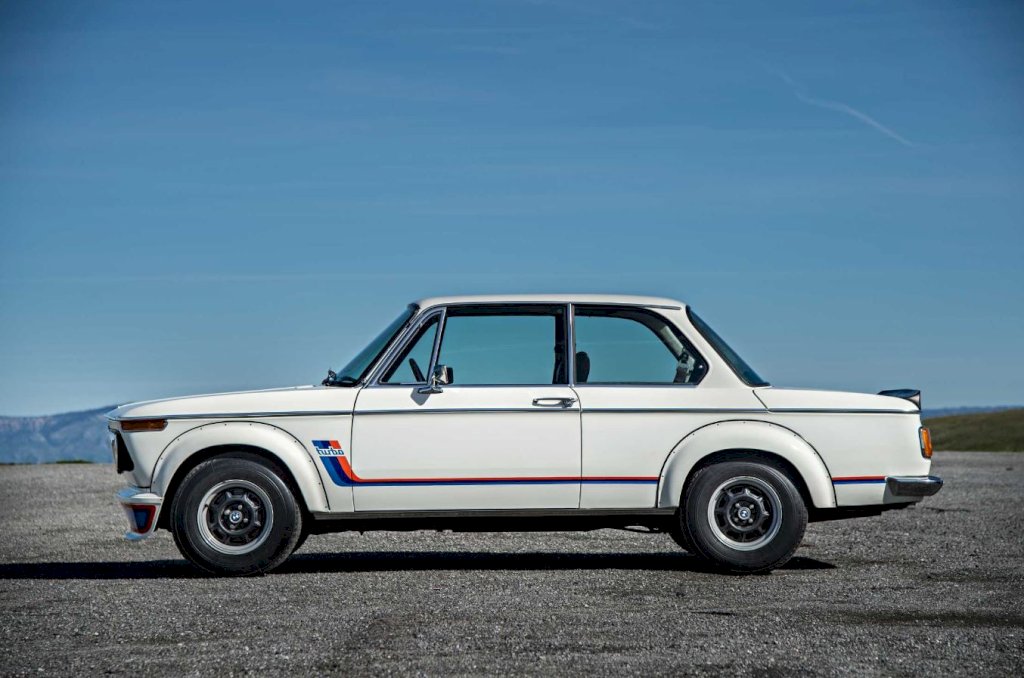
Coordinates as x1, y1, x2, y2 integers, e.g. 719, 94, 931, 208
108, 295, 942, 575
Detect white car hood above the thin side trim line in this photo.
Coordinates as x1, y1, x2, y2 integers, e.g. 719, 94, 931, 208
106, 386, 358, 419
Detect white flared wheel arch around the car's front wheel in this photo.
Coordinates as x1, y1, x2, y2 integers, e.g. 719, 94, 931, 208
152, 421, 329, 511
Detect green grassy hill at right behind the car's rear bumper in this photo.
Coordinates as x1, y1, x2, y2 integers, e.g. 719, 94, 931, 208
925, 408, 1024, 452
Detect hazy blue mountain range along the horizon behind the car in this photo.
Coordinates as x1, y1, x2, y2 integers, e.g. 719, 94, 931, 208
0, 405, 1019, 464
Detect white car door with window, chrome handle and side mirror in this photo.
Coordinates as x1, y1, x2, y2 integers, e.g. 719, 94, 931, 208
349, 304, 581, 511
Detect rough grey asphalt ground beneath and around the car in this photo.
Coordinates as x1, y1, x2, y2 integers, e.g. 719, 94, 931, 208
0, 453, 1024, 676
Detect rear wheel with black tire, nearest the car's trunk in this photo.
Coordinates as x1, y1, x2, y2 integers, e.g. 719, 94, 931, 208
677, 461, 807, 573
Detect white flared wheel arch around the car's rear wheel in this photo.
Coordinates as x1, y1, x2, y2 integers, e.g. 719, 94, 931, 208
657, 420, 836, 508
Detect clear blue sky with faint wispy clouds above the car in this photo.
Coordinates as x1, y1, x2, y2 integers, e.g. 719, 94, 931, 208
0, 0, 1024, 415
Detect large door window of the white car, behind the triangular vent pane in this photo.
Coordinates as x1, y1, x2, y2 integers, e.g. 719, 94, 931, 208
437, 306, 567, 385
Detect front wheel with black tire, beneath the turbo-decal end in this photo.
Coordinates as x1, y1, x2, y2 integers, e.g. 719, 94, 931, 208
171, 454, 302, 576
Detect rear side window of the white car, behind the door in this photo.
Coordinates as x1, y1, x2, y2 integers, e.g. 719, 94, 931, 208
573, 306, 708, 384
